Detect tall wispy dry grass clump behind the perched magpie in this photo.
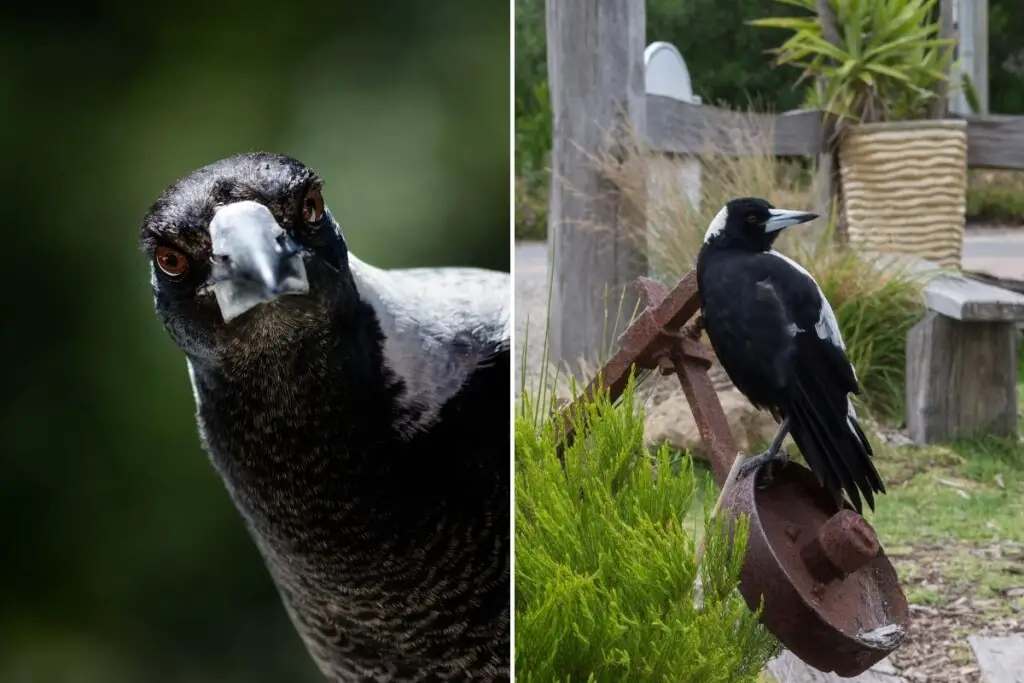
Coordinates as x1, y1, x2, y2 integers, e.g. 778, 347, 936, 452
596, 107, 924, 421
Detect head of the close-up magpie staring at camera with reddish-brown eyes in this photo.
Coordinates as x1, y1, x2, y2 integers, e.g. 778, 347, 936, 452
140, 153, 351, 360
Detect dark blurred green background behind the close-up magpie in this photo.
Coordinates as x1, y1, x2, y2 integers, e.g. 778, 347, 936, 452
0, 0, 511, 683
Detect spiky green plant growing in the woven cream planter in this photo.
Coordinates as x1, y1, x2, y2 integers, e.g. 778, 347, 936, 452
750, 0, 954, 122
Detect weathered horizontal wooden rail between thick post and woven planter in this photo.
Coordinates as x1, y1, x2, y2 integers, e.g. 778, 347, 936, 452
647, 95, 824, 157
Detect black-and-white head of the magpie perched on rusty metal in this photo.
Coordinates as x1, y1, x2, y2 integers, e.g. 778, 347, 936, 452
705, 197, 818, 251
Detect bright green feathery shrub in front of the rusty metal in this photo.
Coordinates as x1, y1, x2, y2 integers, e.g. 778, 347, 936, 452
515, 376, 777, 683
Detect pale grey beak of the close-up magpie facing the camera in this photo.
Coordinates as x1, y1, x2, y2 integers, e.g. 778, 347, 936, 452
203, 200, 309, 323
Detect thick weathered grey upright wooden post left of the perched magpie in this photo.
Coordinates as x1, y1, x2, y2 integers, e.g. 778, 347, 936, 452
546, 0, 647, 375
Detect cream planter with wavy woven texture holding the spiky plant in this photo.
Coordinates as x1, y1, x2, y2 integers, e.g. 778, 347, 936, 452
839, 119, 967, 268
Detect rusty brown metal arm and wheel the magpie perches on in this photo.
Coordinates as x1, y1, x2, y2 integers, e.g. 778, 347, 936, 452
558, 271, 909, 677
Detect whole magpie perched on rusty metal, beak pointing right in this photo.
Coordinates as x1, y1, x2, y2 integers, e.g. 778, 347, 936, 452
696, 197, 886, 513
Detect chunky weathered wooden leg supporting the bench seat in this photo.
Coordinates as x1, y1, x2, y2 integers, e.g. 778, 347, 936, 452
906, 311, 1018, 443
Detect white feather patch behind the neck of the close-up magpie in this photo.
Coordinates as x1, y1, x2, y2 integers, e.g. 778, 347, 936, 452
348, 253, 512, 438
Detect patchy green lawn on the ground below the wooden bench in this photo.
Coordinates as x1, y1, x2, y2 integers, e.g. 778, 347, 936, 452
865, 349, 1024, 617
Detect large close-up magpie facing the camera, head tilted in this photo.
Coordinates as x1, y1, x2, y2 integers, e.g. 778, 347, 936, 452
141, 154, 511, 682
